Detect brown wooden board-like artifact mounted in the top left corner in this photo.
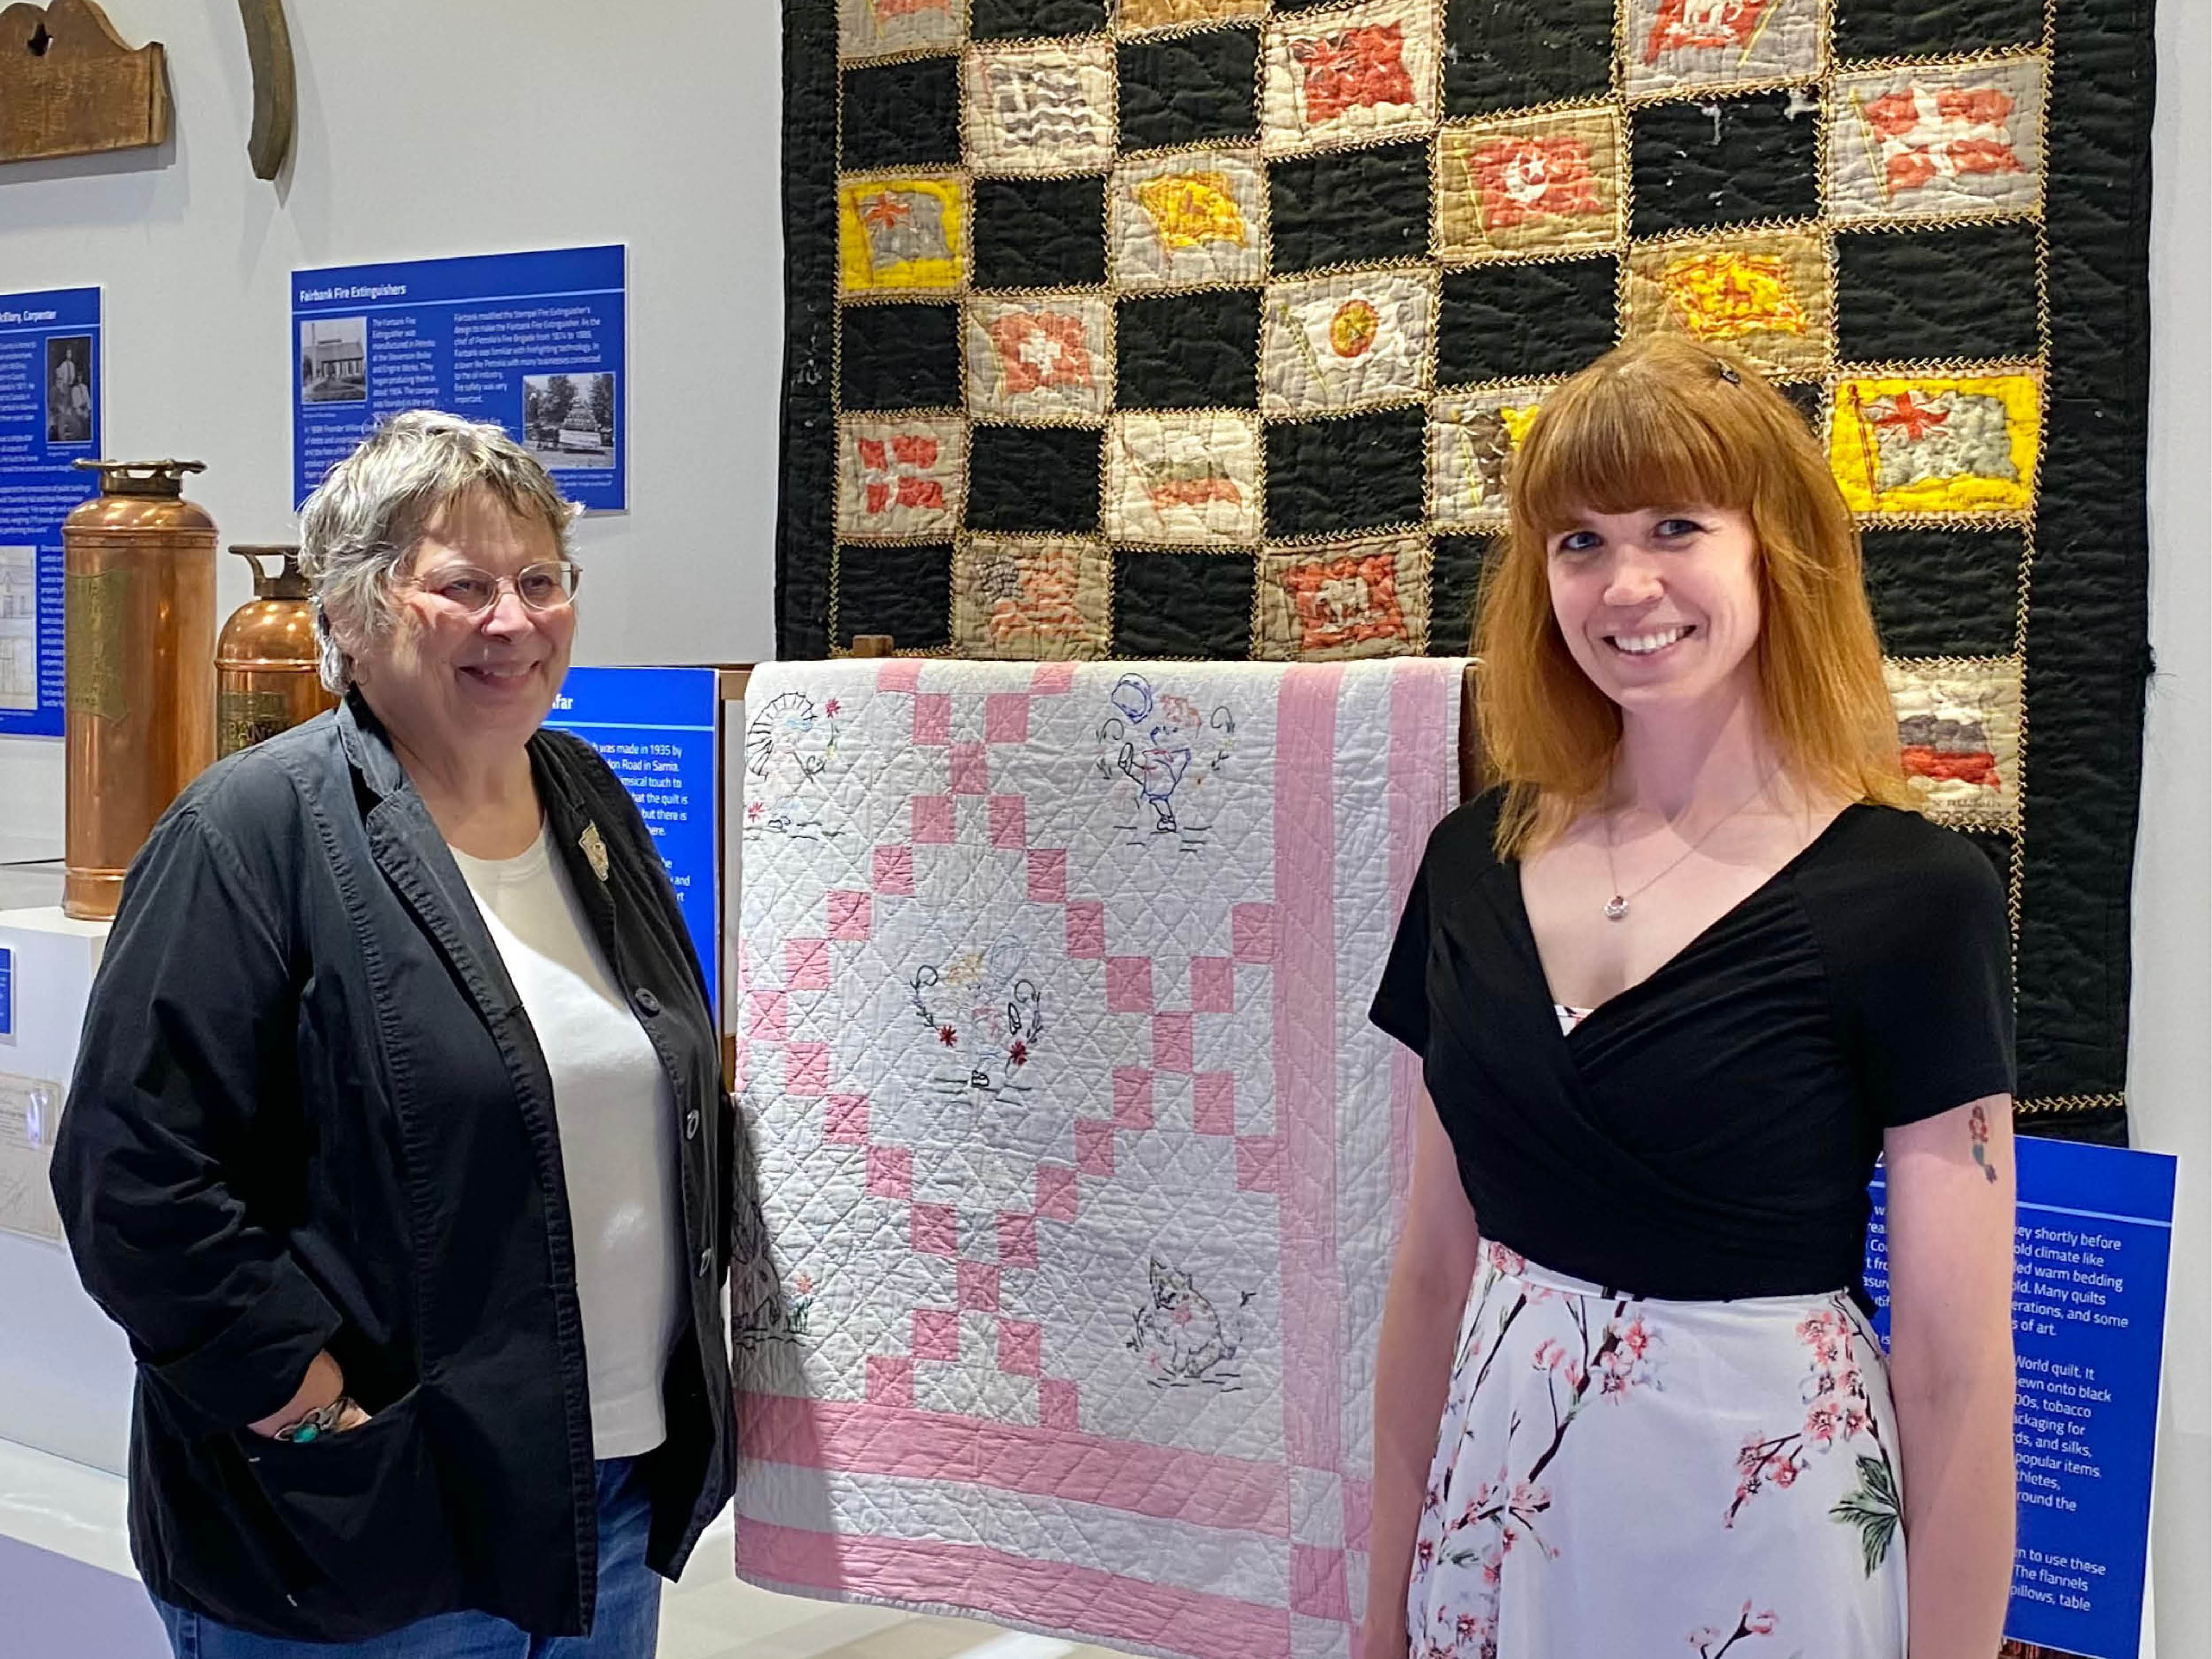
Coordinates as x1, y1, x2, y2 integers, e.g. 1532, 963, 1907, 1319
0, 0, 170, 161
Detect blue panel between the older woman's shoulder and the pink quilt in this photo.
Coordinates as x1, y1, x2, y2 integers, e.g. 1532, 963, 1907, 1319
546, 668, 721, 1009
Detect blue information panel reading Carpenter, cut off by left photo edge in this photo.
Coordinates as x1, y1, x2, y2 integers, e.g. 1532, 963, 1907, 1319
0, 288, 102, 737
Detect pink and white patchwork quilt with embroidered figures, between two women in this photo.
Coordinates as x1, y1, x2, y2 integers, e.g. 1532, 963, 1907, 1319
732, 659, 1462, 1659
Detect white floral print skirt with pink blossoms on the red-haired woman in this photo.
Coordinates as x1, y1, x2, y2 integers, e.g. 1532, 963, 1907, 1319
1407, 1243, 1905, 1659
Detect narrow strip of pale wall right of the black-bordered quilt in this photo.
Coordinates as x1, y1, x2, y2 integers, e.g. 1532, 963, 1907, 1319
2132, 0, 2212, 1659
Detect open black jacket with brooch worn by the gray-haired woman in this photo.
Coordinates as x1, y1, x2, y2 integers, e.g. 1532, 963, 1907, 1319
53, 694, 734, 1641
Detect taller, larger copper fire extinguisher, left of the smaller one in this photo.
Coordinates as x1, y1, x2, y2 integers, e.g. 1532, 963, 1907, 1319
62, 460, 214, 920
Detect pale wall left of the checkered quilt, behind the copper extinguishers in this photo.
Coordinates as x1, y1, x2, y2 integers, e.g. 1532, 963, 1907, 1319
0, 0, 783, 863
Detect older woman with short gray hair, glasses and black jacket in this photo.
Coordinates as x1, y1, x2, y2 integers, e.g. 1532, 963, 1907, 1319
53, 411, 737, 1659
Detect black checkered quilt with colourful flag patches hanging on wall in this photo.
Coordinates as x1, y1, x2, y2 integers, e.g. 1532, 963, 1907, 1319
777, 0, 2152, 1137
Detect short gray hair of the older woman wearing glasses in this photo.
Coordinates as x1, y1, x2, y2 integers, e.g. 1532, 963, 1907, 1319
299, 409, 580, 694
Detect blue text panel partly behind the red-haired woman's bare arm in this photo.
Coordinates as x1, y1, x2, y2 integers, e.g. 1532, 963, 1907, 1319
1867, 1137, 2174, 1659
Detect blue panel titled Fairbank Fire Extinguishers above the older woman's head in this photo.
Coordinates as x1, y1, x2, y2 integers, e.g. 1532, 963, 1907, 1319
292, 248, 631, 509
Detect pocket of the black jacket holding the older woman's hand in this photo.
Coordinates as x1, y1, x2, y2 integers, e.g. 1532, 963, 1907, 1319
246, 1389, 460, 1628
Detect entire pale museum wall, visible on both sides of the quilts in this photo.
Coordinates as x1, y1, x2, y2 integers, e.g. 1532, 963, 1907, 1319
0, 0, 2212, 1659
